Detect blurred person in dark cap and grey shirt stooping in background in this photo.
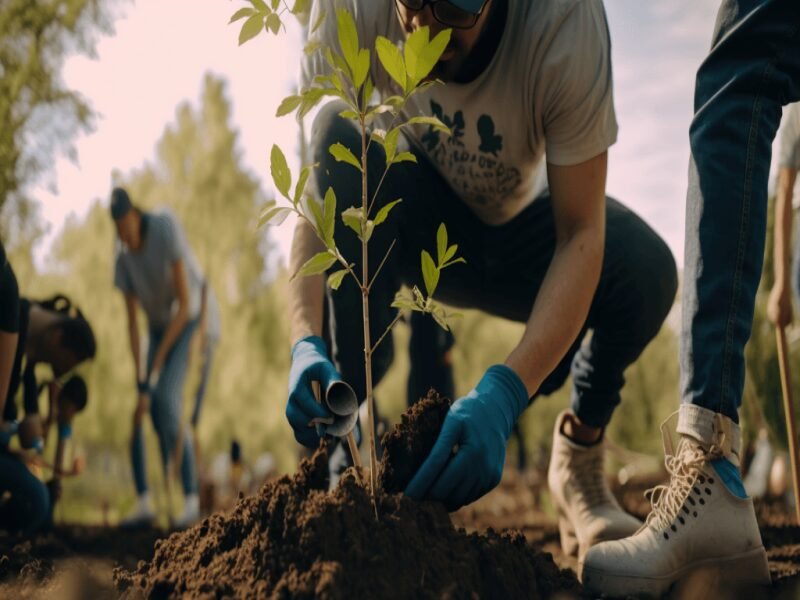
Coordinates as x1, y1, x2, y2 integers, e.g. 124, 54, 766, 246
111, 187, 219, 527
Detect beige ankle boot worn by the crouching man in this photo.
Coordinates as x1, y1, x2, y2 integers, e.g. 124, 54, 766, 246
547, 411, 642, 559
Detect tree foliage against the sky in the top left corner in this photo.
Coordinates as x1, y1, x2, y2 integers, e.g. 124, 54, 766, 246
0, 0, 116, 238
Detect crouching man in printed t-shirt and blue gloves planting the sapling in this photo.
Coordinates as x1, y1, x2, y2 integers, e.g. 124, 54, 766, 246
286, 0, 677, 555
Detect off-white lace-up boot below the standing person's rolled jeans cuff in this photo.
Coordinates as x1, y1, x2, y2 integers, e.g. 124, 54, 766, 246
582, 404, 770, 598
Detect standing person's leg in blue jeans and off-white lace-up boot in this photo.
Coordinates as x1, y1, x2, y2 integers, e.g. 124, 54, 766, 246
583, 0, 800, 597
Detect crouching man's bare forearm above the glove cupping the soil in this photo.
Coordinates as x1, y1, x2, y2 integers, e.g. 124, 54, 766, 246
506, 225, 605, 396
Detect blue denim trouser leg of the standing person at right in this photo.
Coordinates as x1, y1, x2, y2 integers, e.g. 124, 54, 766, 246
681, 0, 800, 422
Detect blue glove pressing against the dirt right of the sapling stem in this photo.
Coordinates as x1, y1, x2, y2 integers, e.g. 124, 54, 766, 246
406, 365, 529, 511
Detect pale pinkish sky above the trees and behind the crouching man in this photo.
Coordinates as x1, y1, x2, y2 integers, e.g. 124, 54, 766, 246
35, 0, 780, 264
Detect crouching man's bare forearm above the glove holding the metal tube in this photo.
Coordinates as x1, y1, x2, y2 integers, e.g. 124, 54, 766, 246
289, 219, 325, 344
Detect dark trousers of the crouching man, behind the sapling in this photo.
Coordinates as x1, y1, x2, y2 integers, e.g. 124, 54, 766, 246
312, 103, 677, 427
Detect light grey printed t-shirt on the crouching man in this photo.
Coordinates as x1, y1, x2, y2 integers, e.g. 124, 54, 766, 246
301, 0, 617, 225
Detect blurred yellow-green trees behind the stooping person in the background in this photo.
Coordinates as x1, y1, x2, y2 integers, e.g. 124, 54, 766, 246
10, 76, 297, 518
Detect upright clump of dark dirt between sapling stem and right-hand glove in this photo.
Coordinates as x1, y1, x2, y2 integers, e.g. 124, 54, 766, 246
378, 390, 450, 494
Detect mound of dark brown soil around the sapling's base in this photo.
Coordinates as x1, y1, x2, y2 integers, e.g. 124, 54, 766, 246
115, 394, 579, 598
